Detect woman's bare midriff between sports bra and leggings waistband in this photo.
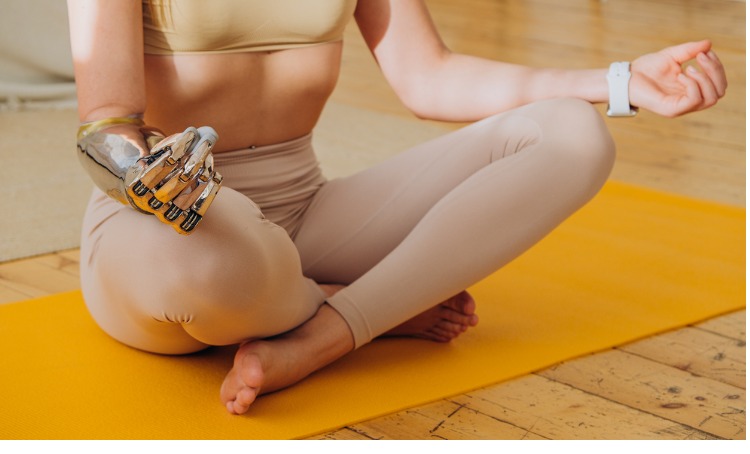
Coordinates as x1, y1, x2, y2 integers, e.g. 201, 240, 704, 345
145, 41, 342, 153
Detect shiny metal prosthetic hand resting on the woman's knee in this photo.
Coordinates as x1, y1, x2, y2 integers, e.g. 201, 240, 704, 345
78, 117, 222, 235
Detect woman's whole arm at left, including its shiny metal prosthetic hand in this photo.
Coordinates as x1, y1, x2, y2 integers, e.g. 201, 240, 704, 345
68, 0, 221, 234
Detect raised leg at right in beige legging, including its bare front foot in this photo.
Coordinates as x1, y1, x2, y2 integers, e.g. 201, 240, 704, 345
221, 99, 614, 413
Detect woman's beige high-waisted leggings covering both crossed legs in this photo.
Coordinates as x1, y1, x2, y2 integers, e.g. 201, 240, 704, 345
81, 99, 614, 353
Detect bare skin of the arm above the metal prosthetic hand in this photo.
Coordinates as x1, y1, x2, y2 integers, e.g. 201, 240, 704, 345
68, 0, 146, 121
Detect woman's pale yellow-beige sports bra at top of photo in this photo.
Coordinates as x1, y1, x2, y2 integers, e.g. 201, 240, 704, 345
142, 0, 357, 55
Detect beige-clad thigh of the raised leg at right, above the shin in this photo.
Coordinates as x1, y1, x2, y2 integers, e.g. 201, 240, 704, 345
295, 107, 539, 284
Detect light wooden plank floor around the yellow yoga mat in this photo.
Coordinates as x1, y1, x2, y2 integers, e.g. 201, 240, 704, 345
0, 0, 746, 439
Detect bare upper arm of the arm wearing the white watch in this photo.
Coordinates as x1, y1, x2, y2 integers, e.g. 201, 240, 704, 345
355, 0, 449, 105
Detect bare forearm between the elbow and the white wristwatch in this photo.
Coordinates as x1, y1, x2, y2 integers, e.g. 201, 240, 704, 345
403, 53, 608, 121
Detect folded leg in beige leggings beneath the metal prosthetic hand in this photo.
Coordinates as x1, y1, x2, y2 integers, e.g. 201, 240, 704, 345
81, 188, 323, 353
